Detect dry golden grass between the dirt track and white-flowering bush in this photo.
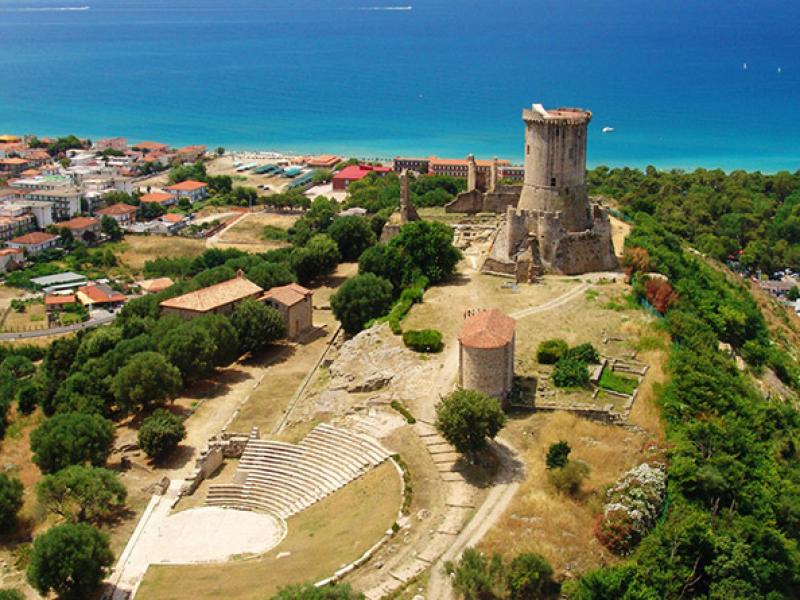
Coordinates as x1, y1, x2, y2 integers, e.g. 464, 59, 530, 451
479, 412, 660, 575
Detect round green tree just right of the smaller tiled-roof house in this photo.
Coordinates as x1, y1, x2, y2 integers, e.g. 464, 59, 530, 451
331, 273, 392, 335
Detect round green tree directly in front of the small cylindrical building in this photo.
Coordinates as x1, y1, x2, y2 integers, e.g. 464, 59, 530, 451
436, 390, 506, 458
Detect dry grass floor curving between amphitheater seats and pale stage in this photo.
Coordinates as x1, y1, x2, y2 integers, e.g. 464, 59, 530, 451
137, 463, 401, 600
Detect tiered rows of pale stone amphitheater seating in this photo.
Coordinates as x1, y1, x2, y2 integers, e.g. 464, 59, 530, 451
206, 424, 390, 519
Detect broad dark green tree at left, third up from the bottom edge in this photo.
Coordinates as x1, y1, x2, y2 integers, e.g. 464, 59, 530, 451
31, 413, 114, 473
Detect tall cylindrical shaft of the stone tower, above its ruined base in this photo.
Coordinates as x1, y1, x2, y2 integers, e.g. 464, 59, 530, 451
518, 104, 592, 231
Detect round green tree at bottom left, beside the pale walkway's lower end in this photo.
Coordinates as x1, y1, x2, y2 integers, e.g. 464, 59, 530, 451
27, 523, 114, 600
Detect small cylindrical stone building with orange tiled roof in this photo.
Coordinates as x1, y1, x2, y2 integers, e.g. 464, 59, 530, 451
458, 309, 516, 406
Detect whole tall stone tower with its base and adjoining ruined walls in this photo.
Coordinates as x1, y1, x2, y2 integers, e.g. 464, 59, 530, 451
446, 104, 618, 281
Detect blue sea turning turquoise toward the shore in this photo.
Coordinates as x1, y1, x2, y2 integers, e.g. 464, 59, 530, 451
0, 0, 800, 171
